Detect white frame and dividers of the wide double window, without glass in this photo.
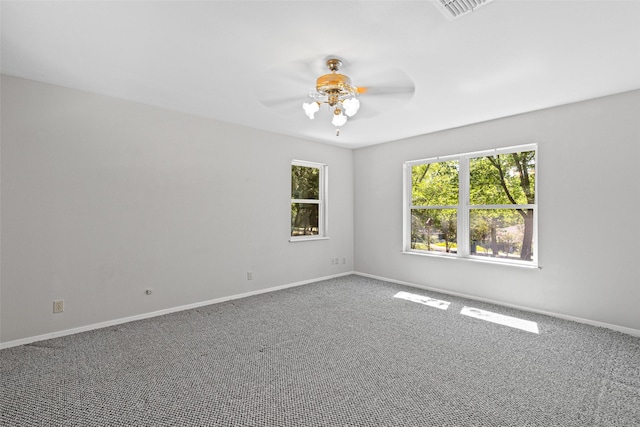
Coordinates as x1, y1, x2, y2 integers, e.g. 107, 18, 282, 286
402, 144, 539, 268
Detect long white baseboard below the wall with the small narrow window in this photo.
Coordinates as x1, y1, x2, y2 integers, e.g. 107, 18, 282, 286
0, 271, 354, 350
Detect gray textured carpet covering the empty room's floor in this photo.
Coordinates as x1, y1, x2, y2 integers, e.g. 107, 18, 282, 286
0, 276, 640, 427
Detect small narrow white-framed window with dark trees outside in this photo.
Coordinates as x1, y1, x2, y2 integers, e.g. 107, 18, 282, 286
291, 160, 327, 241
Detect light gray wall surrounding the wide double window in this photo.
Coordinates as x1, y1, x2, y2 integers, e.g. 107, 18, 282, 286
355, 91, 640, 333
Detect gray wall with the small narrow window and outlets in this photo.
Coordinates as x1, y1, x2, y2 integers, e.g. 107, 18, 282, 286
0, 76, 354, 343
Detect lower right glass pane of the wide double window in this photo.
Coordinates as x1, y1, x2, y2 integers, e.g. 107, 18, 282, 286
469, 209, 533, 261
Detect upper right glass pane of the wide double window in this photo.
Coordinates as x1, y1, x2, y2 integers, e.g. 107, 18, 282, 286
469, 151, 536, 205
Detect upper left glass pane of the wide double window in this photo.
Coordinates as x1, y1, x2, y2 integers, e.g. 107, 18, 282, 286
411, 160, 458, 206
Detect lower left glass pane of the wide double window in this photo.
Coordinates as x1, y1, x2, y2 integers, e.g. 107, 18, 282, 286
411, 209, 458, 253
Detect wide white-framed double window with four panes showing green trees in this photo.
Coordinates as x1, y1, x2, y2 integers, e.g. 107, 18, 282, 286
404, 145, 538, 266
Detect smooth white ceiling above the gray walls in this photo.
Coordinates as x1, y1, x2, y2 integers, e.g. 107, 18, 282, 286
0, 0, 640, 148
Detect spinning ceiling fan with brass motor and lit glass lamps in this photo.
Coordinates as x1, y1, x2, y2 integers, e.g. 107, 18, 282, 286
259, 57, 415, 136
